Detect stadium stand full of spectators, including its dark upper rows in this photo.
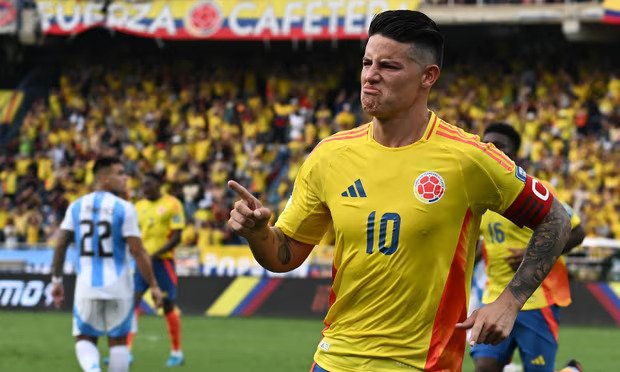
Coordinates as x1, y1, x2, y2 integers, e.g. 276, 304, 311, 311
0, 1, 620, 284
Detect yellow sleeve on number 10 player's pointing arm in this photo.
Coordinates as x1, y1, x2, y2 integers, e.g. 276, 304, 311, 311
275, 146, 331, 244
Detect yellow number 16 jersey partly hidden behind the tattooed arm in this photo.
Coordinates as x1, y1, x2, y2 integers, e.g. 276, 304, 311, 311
480, 181, 581, 310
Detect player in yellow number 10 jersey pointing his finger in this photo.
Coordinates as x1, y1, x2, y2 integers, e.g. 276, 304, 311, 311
228, 10, 570, 372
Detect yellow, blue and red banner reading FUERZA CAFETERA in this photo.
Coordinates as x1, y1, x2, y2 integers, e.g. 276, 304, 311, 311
36, 0, 420, 40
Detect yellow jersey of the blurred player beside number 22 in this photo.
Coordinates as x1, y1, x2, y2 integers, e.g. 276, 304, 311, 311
136, 194, 185, 259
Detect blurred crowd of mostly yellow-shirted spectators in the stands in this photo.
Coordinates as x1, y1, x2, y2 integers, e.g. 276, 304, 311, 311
0, 57, 620, 247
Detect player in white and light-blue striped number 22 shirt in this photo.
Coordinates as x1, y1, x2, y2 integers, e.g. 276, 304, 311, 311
52, 157, 162, 371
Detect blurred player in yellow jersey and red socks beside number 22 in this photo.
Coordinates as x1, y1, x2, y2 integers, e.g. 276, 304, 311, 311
129, 173, 185, 367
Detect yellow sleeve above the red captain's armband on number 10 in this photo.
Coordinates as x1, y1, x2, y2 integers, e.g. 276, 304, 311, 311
463, 143, 527, 218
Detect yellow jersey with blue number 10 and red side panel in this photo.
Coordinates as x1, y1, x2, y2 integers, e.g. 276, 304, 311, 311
276, 112, 548, 372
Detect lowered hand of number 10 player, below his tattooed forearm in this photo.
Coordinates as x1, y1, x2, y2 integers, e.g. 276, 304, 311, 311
456, 296, 520, 346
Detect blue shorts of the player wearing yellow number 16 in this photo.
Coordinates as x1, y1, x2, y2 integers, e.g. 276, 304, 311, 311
470, 305, 560, 372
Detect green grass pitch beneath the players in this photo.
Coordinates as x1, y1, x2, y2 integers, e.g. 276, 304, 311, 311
0, 312, 620, 372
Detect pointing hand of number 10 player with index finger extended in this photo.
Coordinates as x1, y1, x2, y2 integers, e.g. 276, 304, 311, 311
228, 181, 271, 238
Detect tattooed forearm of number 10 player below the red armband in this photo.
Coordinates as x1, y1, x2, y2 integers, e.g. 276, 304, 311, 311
508, 200, 570, 304
